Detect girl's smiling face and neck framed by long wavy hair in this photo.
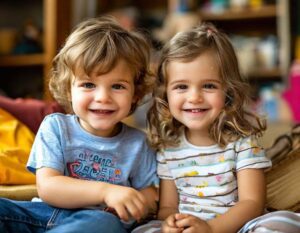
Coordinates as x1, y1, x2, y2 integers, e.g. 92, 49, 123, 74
167, 52, 225, 145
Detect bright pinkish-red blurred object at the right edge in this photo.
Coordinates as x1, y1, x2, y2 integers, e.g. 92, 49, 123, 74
282, 60, 300, 123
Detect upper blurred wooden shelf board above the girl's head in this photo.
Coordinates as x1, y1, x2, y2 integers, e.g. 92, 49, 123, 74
200, 5, 277, 21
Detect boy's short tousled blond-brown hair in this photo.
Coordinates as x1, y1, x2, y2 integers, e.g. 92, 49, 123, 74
49, 16, 154, 113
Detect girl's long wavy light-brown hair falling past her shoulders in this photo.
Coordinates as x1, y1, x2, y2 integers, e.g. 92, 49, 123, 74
147, 23, 266, 150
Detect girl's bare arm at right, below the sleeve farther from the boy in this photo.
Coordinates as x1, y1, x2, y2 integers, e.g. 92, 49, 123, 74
208, 169, 266, 233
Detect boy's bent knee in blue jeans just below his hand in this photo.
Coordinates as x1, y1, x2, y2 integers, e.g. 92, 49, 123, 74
47, 209, 127, 233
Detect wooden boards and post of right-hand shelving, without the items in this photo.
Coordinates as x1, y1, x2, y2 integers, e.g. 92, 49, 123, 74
199, 0, 291, 82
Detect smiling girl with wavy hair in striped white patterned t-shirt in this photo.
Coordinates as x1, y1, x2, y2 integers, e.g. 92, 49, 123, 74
134, 24, 300, 233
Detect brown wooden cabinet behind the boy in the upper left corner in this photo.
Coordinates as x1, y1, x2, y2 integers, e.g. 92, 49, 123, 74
0, 0, 71, 99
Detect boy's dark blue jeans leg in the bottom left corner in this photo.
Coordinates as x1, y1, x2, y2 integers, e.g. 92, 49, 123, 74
0, 198, 54, 233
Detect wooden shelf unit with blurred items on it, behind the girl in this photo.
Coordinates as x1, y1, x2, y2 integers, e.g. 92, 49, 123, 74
199, 0, 291, 83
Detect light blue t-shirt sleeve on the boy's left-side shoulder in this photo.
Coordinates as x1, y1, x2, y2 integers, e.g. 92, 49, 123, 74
27, 115, 64, 173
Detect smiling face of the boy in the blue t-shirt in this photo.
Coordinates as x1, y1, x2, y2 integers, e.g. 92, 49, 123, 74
71, 59, 136, 137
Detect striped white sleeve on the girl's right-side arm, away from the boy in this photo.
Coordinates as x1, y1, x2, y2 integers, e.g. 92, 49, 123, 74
235, 137, 272, 170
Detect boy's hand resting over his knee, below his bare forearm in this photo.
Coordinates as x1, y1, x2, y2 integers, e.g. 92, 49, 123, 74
104, 185, 147, 221
